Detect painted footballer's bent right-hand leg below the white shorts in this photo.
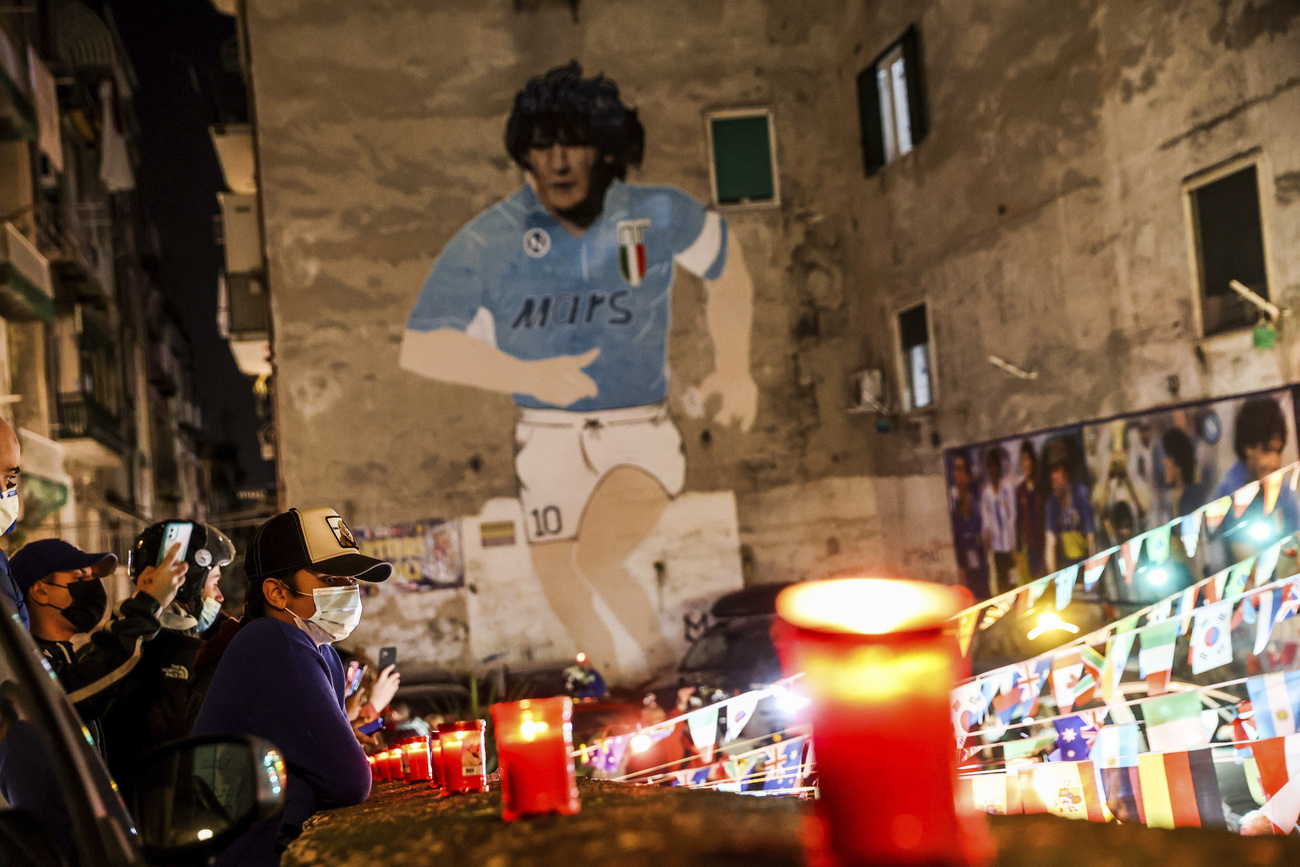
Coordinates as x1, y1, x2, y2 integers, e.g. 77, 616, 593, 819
575, 467, 668, 655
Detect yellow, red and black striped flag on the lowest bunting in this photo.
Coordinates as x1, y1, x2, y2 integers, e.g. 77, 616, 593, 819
1138, 750, 1226, 828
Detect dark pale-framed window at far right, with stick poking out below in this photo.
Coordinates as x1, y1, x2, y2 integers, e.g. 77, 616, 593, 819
1184, 157, 1269, 337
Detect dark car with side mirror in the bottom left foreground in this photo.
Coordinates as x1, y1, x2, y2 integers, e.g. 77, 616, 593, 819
0, 599, 285, 867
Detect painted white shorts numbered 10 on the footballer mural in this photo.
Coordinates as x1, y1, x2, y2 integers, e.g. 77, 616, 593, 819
515, 404, 686, 542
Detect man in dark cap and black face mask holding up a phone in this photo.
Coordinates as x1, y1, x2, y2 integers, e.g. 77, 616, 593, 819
10, 539, 185, 750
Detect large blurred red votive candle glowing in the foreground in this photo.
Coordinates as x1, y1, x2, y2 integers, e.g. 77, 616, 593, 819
774, 578, 992, 867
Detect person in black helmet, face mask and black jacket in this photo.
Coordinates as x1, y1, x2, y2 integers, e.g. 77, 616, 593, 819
103, 520, 235, 794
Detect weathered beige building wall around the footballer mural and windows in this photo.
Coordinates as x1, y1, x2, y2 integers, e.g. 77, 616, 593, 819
248, 0, 1300, 667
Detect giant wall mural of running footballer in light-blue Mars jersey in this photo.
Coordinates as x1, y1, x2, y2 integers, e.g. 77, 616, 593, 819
400, 61, 758, 663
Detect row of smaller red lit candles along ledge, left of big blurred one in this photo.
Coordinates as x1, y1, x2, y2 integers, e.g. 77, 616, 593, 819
369, 695, 580, 822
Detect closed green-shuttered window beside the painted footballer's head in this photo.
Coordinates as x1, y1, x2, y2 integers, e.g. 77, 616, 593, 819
709, 109, 780, 205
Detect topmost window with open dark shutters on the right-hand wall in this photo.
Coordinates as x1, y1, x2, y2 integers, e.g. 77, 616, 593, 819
858, 25, 928, 175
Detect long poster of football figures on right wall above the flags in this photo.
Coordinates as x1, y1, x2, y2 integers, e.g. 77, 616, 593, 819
944, 387, 1300, 599
